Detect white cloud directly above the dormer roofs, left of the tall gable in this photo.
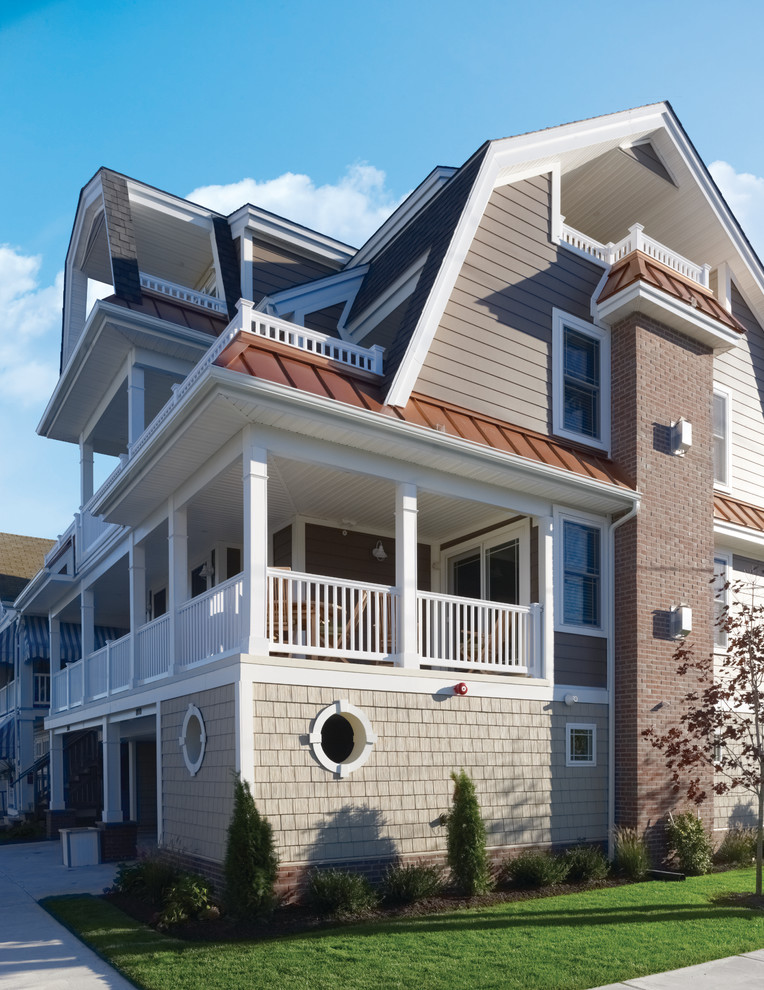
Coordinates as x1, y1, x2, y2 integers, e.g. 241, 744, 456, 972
188, 164, 401, 246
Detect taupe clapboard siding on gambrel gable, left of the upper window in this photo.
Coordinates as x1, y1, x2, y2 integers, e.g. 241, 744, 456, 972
415, 175, 602, 433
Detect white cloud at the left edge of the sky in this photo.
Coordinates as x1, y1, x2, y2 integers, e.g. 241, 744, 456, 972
0, 244, 64, 407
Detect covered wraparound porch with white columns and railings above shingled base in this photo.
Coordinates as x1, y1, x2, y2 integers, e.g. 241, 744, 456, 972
51, 438, 553, 714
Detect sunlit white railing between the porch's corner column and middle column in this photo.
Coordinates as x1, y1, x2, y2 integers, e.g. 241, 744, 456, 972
268, 568, 396, 661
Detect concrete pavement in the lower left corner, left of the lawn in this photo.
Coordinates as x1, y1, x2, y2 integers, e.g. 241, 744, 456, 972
0, 842, 135, 990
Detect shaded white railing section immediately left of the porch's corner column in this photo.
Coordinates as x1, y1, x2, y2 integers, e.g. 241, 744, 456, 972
177, 575, 244, 667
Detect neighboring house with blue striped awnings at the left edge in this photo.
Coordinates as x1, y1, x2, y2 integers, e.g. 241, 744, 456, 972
0, 533, 54, 818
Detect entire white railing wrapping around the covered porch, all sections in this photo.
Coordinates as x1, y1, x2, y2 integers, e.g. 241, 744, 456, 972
47, 568, 543, 713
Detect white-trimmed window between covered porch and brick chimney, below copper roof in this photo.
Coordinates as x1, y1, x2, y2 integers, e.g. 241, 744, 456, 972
558, 516, 604, 632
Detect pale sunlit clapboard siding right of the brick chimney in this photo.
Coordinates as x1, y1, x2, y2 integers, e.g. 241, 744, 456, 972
714, 285, 764, 505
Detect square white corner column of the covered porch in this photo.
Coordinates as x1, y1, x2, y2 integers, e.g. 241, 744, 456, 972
242, 426, 269, 656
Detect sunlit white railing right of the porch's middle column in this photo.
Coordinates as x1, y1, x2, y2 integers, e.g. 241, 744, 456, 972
417, 591, 541, 674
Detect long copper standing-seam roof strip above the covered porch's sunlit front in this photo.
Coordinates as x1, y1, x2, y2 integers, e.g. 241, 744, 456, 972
215, 333, 632, 489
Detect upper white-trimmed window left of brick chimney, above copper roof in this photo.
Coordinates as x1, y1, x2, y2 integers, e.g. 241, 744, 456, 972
552, 309, 610, 450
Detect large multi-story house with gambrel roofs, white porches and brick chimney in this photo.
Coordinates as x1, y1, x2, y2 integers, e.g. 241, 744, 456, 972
11, 103, 764, 885
